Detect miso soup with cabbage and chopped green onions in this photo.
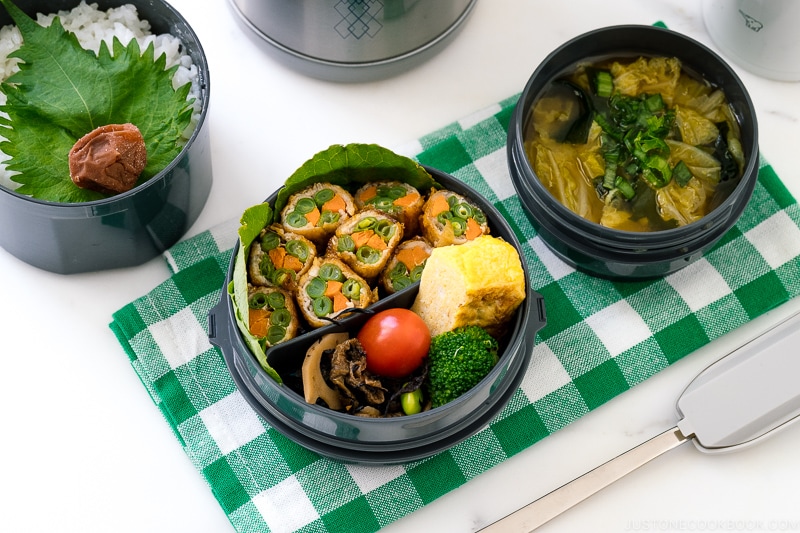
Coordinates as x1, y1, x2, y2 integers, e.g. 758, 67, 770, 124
524, 57, 745, 232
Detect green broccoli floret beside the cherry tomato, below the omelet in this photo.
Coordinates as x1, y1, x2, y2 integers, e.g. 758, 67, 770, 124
428, 326, 498, 407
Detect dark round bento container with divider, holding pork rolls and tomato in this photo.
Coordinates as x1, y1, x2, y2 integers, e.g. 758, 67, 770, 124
209, 167, 545, 464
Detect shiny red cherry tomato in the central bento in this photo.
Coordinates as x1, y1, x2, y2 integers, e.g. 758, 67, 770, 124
356, 309, 431, 378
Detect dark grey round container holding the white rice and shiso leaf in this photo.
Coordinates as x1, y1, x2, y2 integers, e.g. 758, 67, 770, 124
0, 0, 212, 274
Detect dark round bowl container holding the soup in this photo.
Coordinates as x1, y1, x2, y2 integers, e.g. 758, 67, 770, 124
507, 25, 759, 279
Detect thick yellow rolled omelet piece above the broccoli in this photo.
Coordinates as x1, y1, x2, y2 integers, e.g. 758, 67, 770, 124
411, 235, 526, 336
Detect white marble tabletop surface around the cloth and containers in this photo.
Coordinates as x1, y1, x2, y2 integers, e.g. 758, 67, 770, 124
0, 0, 800, 533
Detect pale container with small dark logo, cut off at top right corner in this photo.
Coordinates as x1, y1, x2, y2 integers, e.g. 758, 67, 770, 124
703, 0, 800, 81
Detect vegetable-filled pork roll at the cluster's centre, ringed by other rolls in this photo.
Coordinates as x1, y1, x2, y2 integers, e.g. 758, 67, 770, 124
328, 209, 403, 280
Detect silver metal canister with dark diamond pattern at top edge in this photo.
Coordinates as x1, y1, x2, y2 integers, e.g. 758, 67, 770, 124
230, 0, 477, 82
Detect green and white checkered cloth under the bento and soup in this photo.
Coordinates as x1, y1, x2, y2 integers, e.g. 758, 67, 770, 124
111, 96, 800, 533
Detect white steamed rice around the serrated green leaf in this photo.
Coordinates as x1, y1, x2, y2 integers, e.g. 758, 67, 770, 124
0, 0, 202, 189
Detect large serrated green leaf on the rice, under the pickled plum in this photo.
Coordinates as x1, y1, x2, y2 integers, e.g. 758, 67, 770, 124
0, 0, 192, 202
